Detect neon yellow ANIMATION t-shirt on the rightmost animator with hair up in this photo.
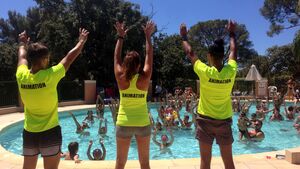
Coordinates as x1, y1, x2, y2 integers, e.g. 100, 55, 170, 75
194, 60, 237, 120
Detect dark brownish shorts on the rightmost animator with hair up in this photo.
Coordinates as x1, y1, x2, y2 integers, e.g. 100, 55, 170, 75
196, 114, 234, 145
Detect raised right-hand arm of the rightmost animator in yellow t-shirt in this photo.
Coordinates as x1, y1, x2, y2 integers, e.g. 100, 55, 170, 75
227, 20, 237, 61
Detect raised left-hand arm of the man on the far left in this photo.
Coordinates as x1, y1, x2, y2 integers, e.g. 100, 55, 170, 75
18, 31, 30, 66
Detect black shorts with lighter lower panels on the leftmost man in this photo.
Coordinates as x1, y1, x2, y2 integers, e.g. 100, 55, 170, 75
23, 126, 62, 157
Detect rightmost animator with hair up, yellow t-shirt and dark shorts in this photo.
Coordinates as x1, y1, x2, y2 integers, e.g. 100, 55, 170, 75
180, 20, 237, 169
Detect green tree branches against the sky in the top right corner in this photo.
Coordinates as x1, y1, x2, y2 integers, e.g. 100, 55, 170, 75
260, 0, 300, 36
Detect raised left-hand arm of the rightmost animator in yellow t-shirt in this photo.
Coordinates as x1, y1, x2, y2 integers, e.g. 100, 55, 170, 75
180, 24, 198, 65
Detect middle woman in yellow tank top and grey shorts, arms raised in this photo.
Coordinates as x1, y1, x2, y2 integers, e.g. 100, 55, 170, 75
114, 21, 155, 169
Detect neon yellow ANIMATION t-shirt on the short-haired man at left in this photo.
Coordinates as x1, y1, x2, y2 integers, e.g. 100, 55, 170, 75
16, 64, 65, 132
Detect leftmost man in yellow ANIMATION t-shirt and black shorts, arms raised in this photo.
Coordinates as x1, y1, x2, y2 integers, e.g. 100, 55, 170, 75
16, 28, 89, 169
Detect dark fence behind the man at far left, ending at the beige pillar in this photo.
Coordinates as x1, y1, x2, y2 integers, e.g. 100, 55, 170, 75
0, 81, 84, 107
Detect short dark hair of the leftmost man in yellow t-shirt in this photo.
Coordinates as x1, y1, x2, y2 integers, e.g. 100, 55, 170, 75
27, 42, 50, 64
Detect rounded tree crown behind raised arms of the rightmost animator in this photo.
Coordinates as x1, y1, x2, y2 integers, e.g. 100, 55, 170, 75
189, 20, 257, 67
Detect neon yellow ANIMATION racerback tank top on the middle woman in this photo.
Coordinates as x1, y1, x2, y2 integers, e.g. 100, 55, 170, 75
117, 74, 150, 127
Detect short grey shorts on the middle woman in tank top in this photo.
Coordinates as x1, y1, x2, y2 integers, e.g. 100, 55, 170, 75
116, 125, 151, 138
